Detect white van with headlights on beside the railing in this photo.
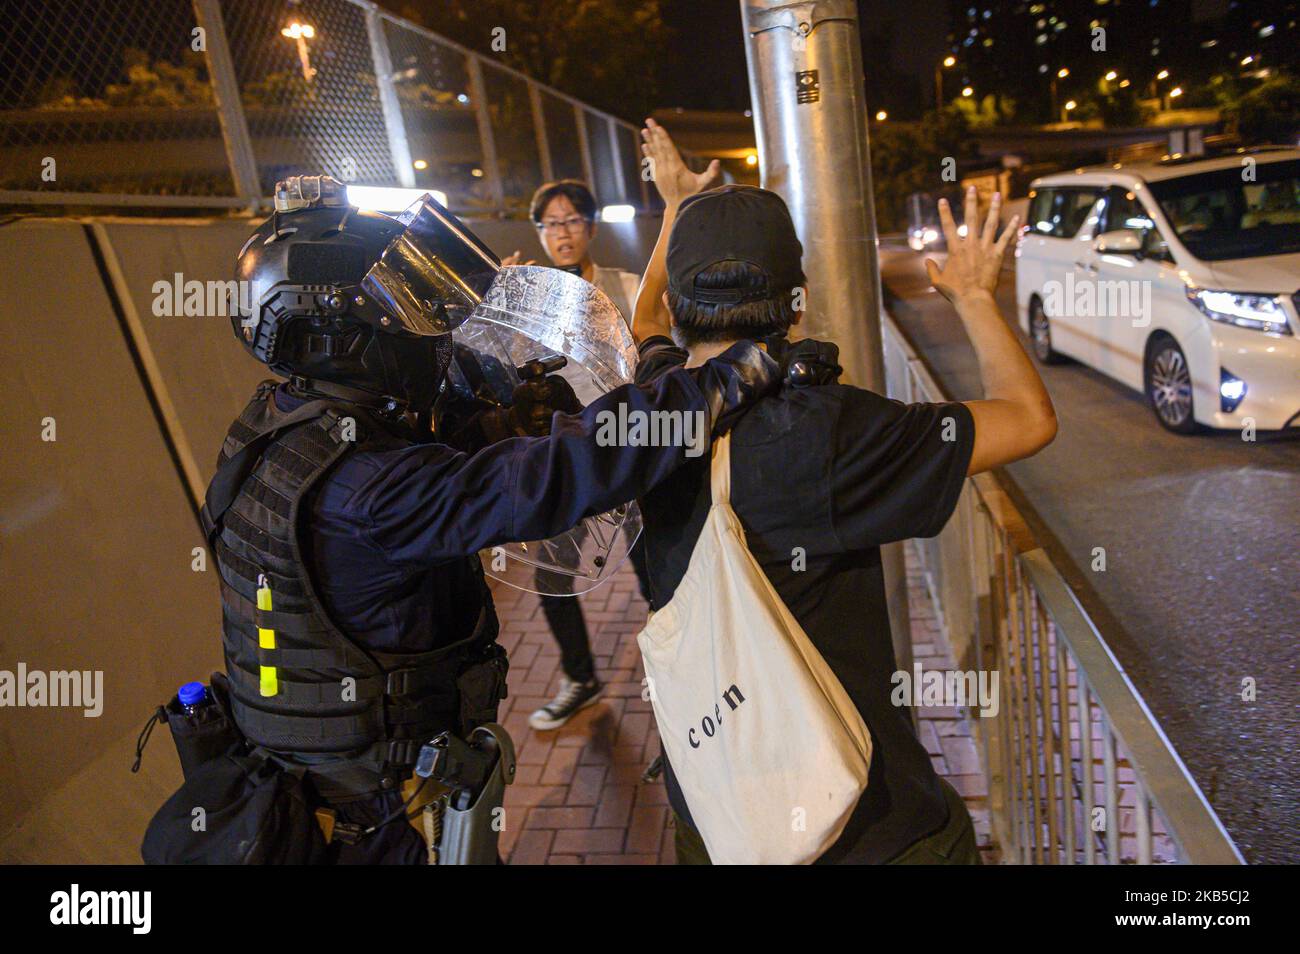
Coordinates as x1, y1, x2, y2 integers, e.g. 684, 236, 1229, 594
1015, 148, 1300, 434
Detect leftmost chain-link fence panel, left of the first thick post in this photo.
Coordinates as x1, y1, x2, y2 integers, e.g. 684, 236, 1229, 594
0, 0, 235, 200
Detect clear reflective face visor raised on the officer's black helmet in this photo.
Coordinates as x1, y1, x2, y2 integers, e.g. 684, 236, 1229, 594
361, 195, 501, 337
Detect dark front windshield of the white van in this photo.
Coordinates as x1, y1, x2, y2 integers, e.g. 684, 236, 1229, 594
1149, 160, 1300, 261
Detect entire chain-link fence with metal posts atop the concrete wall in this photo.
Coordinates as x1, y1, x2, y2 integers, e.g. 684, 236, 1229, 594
0, 0, 654, 214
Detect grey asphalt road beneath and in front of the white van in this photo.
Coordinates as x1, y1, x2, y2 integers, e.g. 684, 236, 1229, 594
881, 242, 1300, 863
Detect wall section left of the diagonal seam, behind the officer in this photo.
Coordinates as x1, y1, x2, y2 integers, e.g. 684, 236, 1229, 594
0, 221, 220, 862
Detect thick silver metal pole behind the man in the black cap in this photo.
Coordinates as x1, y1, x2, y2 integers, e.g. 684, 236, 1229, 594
741, 0, 911, 686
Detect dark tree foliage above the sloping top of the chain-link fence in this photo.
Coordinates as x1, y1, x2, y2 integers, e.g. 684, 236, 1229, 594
384, 0, 666, 122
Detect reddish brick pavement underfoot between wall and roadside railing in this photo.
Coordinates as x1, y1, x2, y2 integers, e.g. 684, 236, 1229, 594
493, 538, 997, 864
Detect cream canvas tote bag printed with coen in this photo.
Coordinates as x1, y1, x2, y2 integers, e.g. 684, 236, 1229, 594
637, 434, 871, 864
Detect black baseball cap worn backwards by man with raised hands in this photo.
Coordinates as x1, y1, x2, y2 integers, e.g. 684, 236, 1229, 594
667, 185, 803, 304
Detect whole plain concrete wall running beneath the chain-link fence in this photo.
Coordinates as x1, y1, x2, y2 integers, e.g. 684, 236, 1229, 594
0, 210, 658, 863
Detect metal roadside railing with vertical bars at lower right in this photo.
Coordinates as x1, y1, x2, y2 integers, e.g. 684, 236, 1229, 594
884, 316, 1243, 864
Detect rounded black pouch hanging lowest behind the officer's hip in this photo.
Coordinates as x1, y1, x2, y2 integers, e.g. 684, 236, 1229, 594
140, 753, 326, 864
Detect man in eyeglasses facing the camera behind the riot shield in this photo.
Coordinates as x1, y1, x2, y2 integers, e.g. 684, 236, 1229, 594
502, 179, 650, 730
